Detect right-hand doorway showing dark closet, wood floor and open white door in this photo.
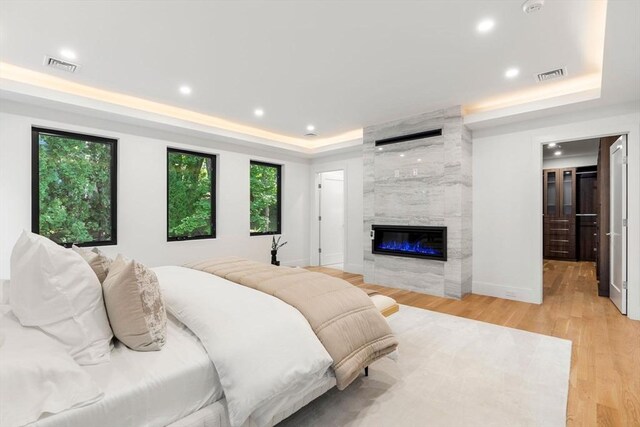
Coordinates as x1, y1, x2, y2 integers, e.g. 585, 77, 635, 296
542, 135, 626, 314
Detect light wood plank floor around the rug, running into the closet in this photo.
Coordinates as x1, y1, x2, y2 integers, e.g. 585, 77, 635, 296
309, 261, 640, 426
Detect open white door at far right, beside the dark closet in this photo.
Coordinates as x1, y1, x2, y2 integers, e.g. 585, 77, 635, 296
609, 135, 627, 314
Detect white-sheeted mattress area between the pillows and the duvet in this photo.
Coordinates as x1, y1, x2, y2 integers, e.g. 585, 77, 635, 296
31, 316, 222, 427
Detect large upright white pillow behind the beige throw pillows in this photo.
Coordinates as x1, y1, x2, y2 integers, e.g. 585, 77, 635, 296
9, 231, 113, 365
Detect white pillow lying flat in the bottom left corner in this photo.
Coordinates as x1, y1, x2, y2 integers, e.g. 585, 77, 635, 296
0, 306, 103, 427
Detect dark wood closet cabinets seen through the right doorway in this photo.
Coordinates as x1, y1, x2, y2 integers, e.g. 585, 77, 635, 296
542, 166, 598, 261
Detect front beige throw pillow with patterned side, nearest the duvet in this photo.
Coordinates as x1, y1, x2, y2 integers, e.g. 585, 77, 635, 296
102, 255, 167, 351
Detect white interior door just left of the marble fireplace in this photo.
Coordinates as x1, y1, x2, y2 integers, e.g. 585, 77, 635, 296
319, 170, 344, 268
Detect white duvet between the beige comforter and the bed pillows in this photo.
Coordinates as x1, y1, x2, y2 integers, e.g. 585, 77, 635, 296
153, 266, 332, 427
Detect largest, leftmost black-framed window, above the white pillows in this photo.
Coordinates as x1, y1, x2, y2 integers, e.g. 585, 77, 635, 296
31, 127, 118, 247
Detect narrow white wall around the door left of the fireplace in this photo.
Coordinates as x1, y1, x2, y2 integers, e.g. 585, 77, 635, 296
309, 147, 363, 273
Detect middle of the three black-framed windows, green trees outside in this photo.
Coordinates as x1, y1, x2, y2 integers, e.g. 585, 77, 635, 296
167, 148, 216, 241
